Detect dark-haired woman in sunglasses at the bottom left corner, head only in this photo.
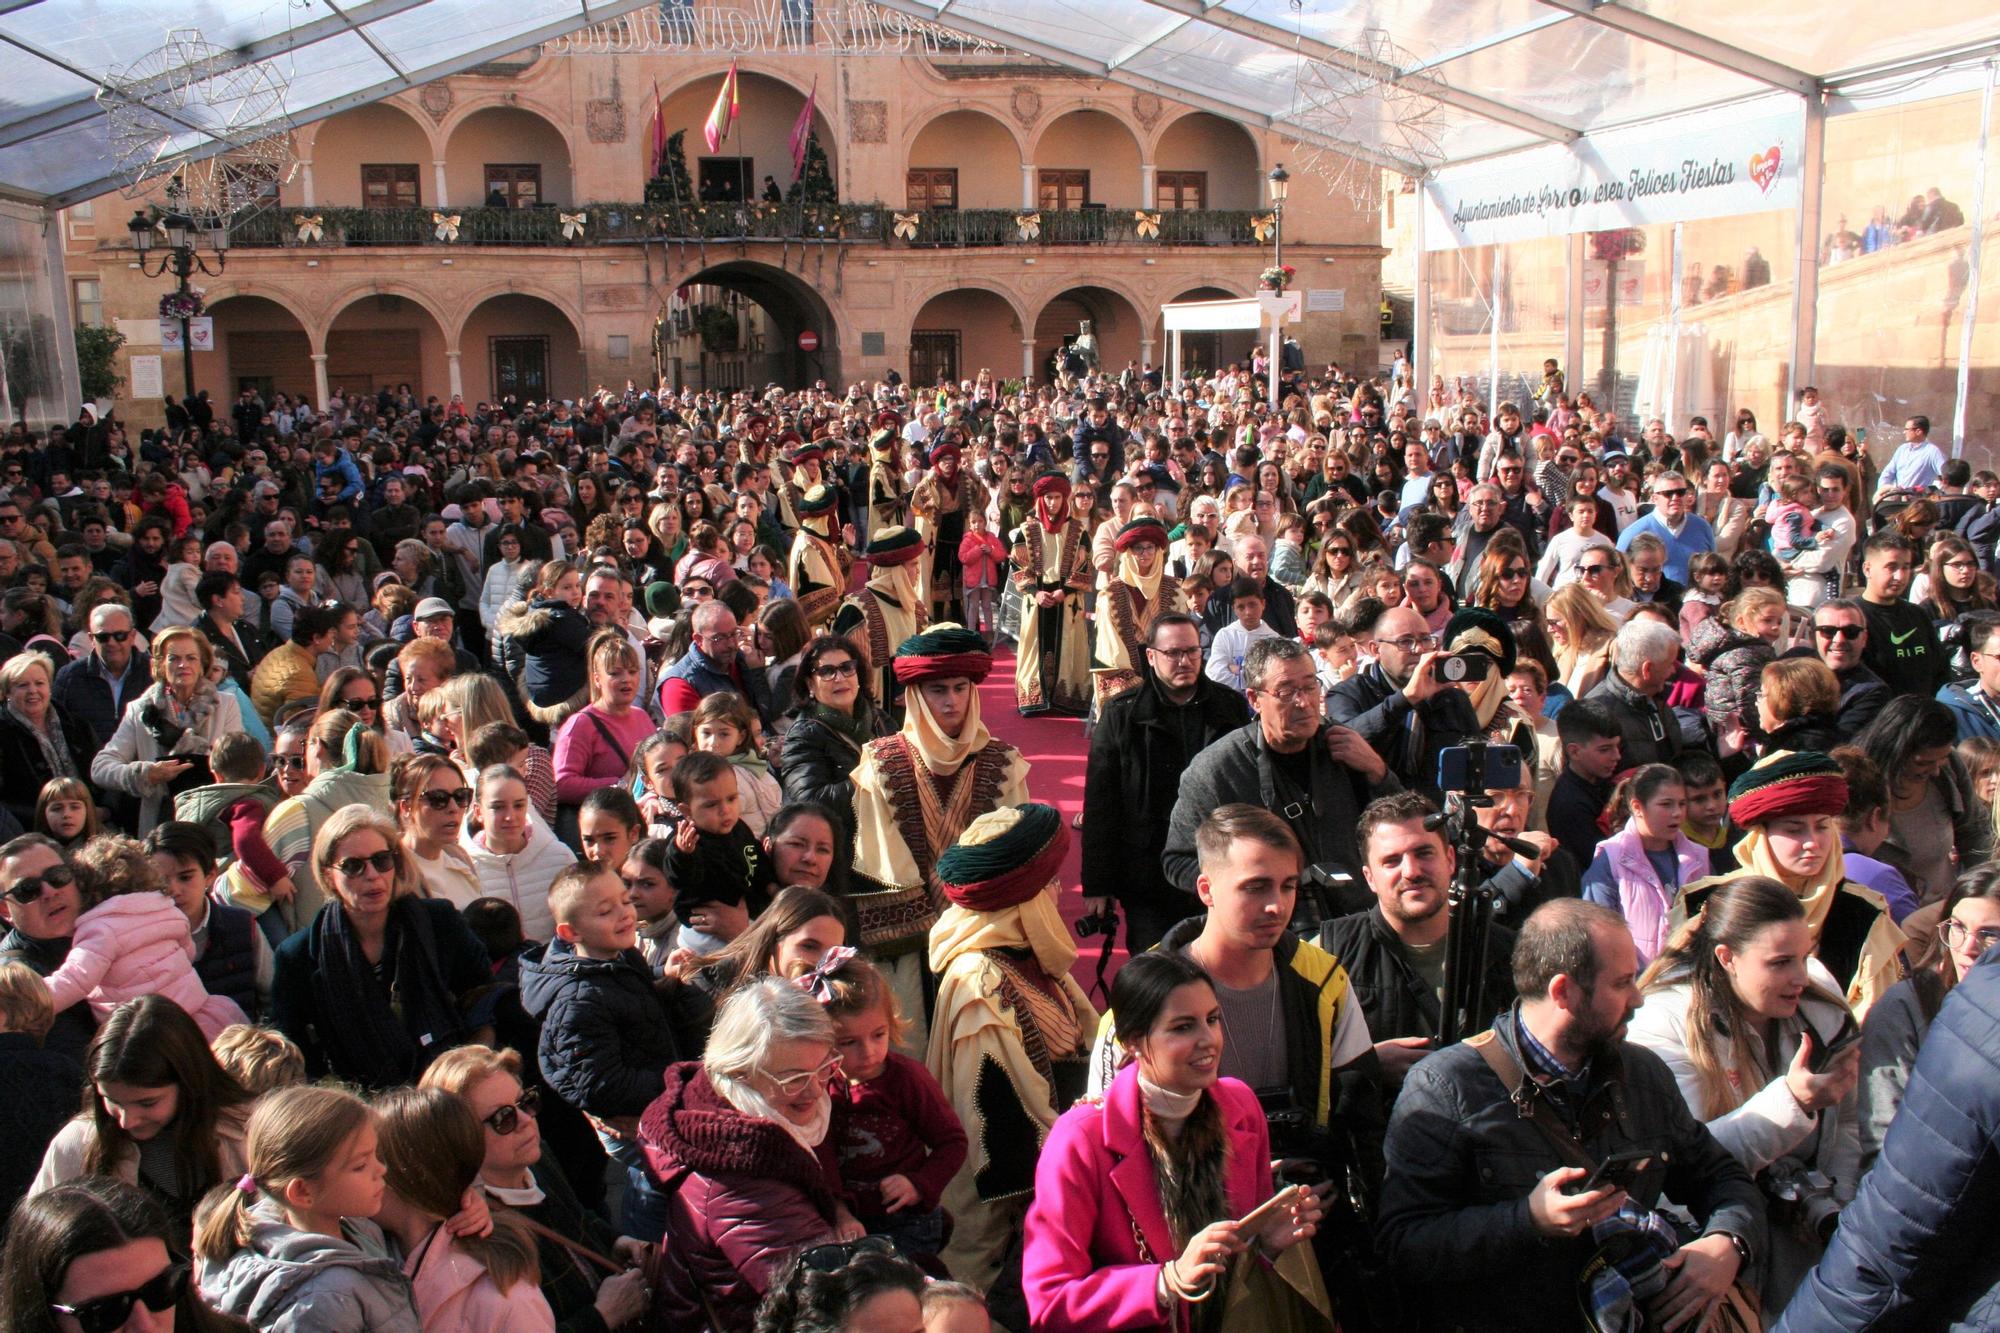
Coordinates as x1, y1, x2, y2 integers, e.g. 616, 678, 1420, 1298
0, 1177, 250, 1333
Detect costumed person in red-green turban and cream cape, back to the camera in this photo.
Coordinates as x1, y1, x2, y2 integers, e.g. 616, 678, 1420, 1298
926, 805, 1098, 1291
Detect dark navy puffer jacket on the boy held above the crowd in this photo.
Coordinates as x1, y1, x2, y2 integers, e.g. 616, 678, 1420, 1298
520, 941, 698, 1117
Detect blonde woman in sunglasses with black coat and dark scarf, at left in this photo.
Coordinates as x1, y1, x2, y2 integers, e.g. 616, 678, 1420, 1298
270, 805, 492, 1089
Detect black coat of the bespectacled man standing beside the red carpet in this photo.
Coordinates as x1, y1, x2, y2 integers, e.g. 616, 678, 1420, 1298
1082, 675, 1250, 901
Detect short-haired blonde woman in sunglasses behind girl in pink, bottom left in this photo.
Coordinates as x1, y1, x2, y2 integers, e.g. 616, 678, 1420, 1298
418, 1045, 650, 1333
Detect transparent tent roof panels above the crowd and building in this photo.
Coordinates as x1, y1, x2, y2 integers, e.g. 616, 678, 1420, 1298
0, 0, 2000, 204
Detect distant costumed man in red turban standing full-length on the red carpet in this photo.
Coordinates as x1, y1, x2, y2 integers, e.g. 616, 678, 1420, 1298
1014, 472, 1096, 717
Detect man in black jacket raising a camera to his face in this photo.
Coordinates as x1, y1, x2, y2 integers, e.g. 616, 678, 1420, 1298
1326, 606, 1492, 801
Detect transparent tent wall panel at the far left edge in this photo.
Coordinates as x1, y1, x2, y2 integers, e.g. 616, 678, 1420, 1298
0, 202, 78, 426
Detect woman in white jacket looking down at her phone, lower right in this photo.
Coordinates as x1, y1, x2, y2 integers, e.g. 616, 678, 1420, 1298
1632, 875, 1860, 1315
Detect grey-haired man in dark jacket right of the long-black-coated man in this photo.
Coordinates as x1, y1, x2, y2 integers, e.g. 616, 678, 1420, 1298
1160, 638, 1402, 923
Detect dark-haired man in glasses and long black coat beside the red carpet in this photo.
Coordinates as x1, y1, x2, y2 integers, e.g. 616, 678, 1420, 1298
1084, 614, 1250, 955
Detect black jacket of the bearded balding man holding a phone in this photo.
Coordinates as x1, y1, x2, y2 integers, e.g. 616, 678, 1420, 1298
1376, 1000, 1766, 1333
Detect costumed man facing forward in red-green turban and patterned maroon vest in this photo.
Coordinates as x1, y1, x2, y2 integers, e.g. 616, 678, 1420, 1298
852, 624, 1028, 1053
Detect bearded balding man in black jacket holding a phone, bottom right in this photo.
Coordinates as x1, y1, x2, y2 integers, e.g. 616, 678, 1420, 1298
1378, 899, 1766, 1333
